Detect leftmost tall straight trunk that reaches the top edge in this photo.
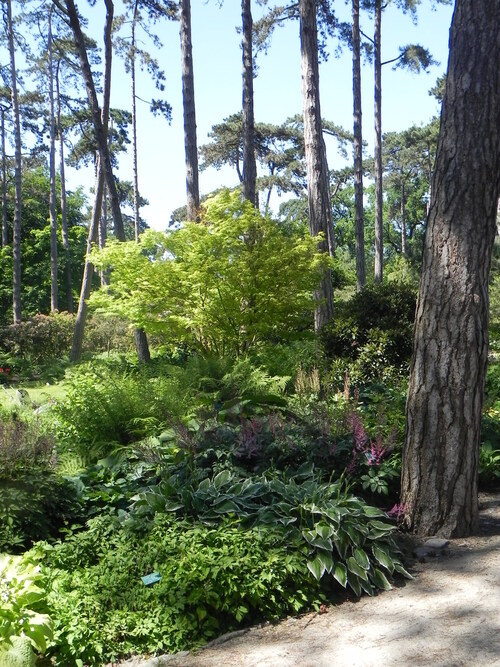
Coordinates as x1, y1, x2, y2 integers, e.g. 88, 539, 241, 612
4, 0, 22, 324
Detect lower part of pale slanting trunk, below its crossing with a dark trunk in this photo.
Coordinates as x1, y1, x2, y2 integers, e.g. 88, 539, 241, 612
69, 159, 104, 363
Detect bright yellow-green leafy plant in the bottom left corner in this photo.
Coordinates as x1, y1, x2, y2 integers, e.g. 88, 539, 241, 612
0, 555, 52, 656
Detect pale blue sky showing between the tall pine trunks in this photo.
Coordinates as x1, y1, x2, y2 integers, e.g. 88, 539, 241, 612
64, 0, 452, 229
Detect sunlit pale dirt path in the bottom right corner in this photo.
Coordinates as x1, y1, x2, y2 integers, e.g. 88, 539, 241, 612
121, 494, 500, 667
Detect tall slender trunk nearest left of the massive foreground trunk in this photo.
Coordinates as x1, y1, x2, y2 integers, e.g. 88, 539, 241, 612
373, 0, 384, 283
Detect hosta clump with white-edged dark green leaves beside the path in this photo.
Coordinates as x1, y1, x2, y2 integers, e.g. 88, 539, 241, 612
131, 465, 407, 595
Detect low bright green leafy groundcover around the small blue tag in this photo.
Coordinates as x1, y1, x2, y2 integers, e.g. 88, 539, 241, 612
34, 514, 316, 667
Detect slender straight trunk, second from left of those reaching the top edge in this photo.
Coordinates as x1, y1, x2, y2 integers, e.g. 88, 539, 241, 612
47, 6, 59, 313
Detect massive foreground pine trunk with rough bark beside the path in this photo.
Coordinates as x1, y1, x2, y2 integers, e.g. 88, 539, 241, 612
401, 0, 500, 537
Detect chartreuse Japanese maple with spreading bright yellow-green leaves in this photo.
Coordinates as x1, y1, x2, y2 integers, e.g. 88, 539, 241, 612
93, 191, 330, 354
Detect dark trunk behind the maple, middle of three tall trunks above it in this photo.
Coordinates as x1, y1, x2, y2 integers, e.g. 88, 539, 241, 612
241, 0, 258, 206
